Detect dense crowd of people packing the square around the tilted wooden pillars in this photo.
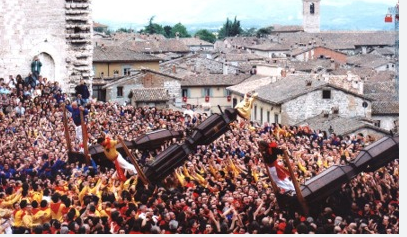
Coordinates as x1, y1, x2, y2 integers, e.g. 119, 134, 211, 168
0, 75, 399, 234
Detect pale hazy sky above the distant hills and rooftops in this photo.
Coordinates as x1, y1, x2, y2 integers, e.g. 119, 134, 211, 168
92, 0, 397, 25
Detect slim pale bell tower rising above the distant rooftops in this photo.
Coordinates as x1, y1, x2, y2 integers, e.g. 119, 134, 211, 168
302, 0, 321, 33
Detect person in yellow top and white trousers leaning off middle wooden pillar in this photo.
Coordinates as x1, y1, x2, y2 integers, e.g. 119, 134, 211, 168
98, 135, 137, 182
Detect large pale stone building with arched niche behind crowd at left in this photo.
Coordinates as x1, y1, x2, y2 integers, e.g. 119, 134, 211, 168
0, 0, 93, 93
